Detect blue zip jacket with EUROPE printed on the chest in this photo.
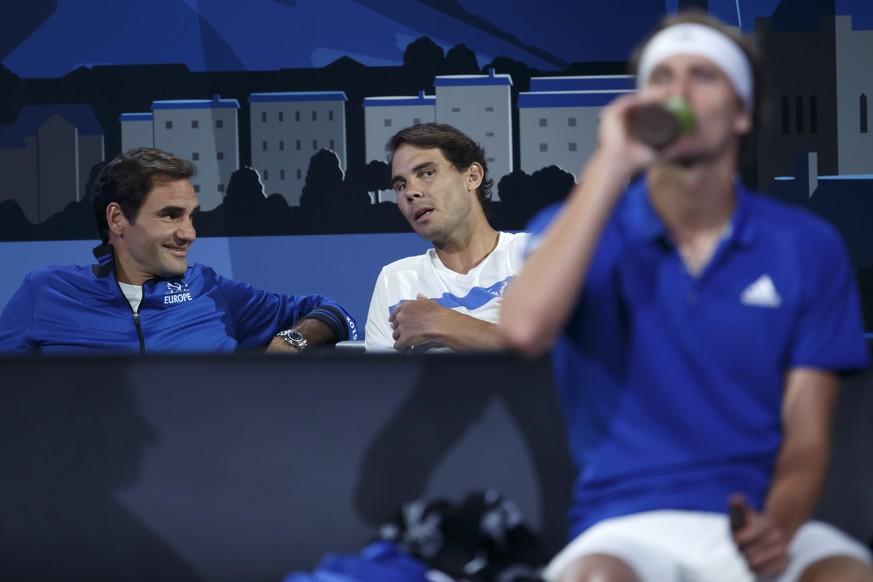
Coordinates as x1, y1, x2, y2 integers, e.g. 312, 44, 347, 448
0, 245, 358, 354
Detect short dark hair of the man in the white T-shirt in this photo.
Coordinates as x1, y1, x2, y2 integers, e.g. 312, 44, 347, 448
388, 123, 494, 210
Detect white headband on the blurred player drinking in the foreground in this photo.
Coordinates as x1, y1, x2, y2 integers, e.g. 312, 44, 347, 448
637, 22, 754, 113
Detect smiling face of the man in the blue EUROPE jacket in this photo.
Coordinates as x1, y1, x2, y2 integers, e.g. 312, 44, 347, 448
106, 180, 200, 285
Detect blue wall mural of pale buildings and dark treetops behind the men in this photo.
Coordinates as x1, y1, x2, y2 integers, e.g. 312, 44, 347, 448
0, 0, 873, 324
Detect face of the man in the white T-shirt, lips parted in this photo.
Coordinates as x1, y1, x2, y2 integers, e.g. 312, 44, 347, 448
391, 144, 484, 245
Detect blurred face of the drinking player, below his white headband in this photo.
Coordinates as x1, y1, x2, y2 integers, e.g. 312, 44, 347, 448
643, 55, 752, 164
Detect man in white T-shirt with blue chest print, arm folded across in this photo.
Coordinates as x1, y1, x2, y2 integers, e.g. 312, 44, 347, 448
364, 123, 527, 352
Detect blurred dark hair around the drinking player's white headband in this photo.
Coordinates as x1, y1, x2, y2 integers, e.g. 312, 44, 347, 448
630, 8, 765, 134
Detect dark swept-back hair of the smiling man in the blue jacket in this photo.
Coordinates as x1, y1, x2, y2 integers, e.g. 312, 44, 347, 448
91, 147, 196, 244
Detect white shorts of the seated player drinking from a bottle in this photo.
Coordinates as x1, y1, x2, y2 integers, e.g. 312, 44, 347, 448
543, 510, 873, 582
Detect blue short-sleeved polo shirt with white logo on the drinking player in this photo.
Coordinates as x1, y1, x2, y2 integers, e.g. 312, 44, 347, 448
531, 179, 868, 536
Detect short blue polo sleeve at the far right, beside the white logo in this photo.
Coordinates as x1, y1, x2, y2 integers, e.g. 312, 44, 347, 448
791, 227, 869, 372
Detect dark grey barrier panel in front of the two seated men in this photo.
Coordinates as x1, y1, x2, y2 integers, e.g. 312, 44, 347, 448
0, 352, 873, 582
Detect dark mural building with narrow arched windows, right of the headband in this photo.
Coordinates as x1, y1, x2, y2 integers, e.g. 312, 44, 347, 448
755, 12, 873, 189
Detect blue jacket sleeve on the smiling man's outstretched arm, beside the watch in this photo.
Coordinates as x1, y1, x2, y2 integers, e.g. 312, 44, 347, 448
212, 272, 358, 348
